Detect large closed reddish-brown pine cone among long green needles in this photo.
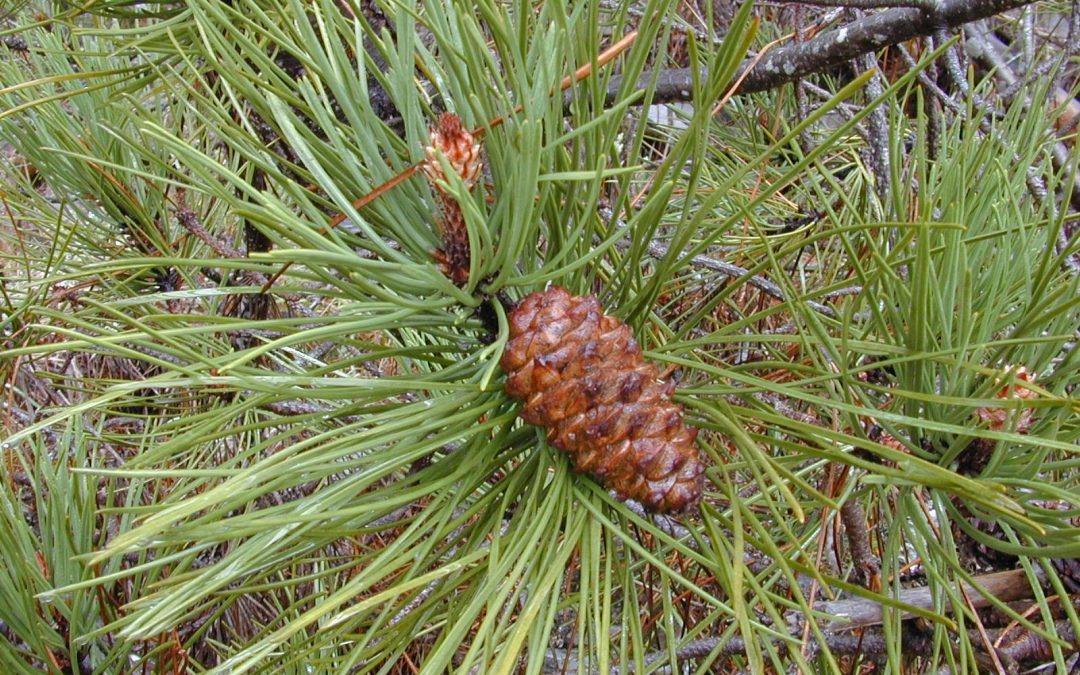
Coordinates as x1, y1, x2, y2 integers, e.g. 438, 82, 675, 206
501, 286, 705, 512
